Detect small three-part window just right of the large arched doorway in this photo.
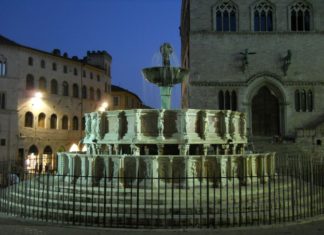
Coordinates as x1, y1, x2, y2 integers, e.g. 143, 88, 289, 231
295, 89, 314, 112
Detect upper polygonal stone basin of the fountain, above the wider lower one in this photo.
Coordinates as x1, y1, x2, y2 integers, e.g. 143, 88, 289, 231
83, 109, 247, 155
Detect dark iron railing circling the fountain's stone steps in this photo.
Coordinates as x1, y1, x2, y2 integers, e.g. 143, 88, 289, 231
0, 157, 324, 228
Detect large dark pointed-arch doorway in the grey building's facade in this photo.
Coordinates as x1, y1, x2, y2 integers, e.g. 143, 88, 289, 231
252, 86, 280, 136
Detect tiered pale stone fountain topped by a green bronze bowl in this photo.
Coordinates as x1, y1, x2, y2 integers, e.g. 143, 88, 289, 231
58, 43, 274, 187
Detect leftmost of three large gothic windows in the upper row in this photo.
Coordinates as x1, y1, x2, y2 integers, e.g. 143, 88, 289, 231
213, 0, 237, 32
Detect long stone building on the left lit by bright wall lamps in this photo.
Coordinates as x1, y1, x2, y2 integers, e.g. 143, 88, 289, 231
0, 36, 112, 170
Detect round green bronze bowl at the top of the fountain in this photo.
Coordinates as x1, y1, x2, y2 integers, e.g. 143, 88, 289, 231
142, 67, 189, 87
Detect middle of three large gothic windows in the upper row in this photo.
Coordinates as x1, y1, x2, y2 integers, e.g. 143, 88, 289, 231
253, 0, 274, 32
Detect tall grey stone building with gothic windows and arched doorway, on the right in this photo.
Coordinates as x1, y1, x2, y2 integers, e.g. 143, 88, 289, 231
180, 0, 324, 143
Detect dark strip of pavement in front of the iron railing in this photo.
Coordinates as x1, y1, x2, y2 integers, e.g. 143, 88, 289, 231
0, 213, 324, 235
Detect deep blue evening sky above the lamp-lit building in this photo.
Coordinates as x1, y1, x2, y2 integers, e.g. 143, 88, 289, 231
0, 0, 181, 107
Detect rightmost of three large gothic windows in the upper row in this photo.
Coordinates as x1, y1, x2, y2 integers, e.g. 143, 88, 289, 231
289, 1, 312, 31
